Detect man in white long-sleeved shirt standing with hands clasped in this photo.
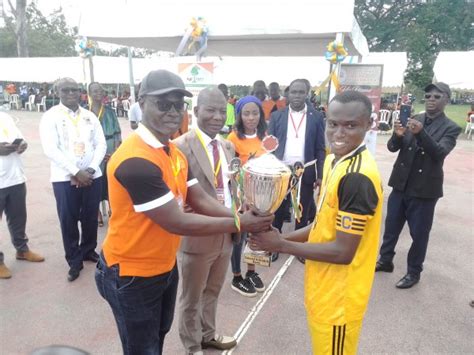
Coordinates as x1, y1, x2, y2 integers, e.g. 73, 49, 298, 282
40, 78, 106, 281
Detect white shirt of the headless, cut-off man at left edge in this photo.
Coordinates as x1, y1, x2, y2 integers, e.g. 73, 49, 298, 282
0, 112, 26, 189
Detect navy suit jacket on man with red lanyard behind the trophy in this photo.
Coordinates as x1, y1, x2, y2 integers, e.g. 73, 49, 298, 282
268, 105, 326, 184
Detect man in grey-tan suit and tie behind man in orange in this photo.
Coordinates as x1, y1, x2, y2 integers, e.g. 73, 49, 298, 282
175, 89, 237, 354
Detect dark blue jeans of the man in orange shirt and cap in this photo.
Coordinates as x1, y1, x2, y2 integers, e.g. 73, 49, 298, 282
95, 255, 179, 355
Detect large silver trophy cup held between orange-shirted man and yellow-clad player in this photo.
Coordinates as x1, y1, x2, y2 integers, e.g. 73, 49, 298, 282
242, 154, 291, 266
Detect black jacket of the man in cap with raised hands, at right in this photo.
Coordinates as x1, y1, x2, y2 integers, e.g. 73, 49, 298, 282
387, 113, 461, 198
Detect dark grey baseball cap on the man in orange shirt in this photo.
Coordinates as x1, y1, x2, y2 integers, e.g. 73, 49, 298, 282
138, 69, 193, 97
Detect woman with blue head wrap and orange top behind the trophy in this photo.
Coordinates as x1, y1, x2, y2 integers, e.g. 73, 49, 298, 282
227, 95, 267, 297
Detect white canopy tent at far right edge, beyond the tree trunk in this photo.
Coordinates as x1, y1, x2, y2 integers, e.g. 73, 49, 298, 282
434, 51, 474, 91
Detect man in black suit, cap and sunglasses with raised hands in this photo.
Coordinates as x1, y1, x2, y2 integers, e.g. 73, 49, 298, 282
375, 82, 461, 289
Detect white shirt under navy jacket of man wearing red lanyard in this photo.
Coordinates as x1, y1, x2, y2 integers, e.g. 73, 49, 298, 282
283, 105, 308, 165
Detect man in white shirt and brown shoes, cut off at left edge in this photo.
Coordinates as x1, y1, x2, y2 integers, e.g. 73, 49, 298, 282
0, 112, 44, 279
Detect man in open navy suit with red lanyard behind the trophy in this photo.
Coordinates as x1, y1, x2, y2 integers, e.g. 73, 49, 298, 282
268, 79, 325, 238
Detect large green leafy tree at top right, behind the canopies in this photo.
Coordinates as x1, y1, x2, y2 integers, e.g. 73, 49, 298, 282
355, 0, 474, 89
